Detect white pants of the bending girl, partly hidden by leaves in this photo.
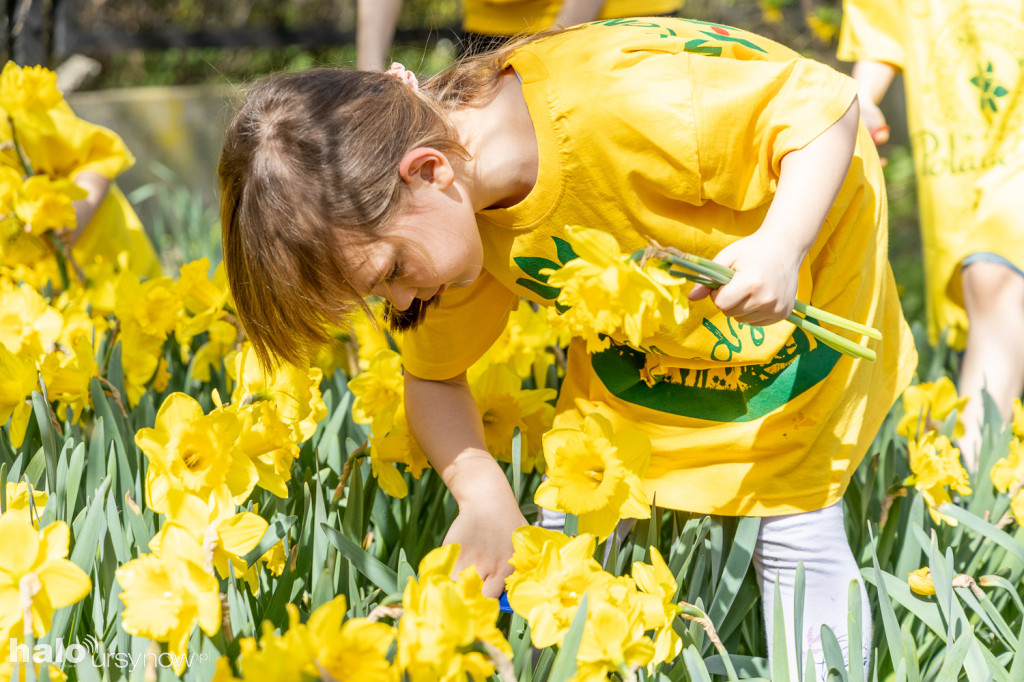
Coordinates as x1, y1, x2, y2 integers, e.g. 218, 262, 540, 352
538, 501, 871, 682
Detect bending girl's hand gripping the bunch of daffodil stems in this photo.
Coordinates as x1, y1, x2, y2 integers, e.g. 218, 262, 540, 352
689, 231, 803, 327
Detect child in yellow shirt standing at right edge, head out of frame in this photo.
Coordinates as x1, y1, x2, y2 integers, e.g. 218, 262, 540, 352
839, 0, 1024, 471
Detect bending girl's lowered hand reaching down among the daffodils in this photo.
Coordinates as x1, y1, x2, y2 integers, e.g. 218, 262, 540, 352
444, 480, 527, 598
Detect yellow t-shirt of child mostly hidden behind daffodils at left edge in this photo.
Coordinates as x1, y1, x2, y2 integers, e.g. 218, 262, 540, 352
0, 102, 161, 278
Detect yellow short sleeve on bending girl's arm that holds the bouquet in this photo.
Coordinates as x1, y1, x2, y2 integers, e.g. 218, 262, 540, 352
690, 57, 857, 211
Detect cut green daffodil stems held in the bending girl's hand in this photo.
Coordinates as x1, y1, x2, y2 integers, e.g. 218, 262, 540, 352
632, 246, 882, 360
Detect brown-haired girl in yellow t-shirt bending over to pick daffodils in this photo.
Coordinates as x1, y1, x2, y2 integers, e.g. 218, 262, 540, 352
219, 15, 915, 671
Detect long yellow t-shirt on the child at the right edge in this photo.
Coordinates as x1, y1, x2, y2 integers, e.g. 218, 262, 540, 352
839, 0, 1024, 348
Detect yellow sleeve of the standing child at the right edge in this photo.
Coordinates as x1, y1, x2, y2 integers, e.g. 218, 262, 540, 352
837, 0, 904, 69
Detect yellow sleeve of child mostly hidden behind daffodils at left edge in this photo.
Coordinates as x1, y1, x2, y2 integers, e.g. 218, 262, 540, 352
28, 104, 135, 180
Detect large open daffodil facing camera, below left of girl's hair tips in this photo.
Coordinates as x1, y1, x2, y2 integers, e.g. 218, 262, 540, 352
135, 393, 258, 512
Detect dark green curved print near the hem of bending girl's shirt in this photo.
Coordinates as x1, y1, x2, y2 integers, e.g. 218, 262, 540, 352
591, 329, 841, 422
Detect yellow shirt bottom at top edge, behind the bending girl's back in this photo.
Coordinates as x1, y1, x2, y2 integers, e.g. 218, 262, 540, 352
462, 0, 683, 36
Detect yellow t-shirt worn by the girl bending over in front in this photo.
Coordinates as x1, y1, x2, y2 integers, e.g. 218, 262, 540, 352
403, 15, 915, 516
